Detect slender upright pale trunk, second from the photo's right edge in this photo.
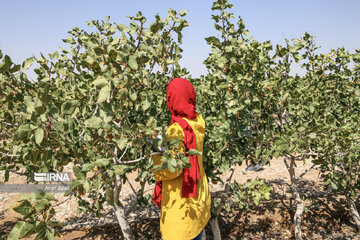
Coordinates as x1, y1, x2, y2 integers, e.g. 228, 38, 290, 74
284, 157, 304, 240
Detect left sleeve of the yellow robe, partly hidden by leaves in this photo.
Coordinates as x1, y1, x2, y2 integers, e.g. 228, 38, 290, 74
152, 123, 184, 181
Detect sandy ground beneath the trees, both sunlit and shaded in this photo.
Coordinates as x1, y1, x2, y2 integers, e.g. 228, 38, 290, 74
0, 159, 360, 239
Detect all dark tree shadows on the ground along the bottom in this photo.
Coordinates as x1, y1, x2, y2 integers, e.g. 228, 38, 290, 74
0, 179, 360, 240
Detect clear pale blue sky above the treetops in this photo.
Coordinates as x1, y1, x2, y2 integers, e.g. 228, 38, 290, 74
0, 0, 360, 77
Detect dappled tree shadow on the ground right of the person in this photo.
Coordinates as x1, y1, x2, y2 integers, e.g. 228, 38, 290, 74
209, 179, 359, 239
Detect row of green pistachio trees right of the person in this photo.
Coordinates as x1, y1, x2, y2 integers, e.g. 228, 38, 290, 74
198, 0, 360, 239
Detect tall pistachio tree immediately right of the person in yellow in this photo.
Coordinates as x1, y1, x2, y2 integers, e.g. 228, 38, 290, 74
196, 0, 276, 239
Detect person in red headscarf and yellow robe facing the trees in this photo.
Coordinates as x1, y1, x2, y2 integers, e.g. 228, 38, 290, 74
152, 78, 211, 240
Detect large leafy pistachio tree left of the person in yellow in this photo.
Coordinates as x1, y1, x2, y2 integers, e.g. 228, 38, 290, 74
0, 9, 188, 239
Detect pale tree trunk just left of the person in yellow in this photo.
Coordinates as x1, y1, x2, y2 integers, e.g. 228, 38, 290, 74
113, 175, 135, 240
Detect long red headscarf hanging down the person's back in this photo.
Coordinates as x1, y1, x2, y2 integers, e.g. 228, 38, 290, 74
153, 78, 200, 207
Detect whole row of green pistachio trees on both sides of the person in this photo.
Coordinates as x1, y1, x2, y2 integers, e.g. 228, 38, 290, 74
0, 0, 360, 239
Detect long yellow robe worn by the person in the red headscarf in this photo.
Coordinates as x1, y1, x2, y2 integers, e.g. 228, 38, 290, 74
153, 114, 211, 240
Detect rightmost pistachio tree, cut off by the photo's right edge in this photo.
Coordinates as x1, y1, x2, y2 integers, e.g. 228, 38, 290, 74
305, 43, 360, 230
